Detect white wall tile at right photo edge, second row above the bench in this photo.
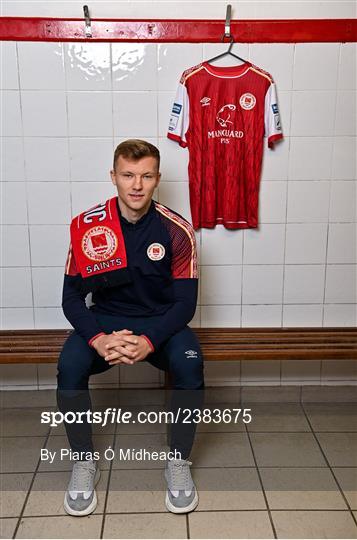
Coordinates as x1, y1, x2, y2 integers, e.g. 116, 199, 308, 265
325, 264, 357, 304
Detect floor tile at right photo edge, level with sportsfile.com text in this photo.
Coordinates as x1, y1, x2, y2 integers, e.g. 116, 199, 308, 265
305, 403, 357, 431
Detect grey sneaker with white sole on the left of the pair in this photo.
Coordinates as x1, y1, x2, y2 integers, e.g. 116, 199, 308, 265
64, 460, 100, 516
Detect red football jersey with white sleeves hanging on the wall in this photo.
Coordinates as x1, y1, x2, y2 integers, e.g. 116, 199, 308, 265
167, 62, 283, 229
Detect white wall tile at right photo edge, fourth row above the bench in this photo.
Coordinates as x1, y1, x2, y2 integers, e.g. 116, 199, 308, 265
330, 181, 357, 223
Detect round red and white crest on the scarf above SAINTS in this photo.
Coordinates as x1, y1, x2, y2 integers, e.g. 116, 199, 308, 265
82, 225, 118, 261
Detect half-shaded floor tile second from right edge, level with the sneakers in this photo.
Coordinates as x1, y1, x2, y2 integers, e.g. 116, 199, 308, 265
260, 468, 347, 510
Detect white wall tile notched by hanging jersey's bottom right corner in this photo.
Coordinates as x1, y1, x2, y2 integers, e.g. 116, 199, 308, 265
243, 224, 285, 264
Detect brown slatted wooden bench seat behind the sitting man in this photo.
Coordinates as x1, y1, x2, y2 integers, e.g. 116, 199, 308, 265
0, 327, 357, 364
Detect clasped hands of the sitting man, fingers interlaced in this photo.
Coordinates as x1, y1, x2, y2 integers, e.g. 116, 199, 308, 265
92, 328, 151, 366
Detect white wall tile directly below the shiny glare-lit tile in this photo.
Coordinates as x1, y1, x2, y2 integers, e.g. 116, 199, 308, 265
67, 92, 113, 137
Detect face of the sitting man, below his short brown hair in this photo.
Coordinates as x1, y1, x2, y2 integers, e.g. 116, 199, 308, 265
110, 156, 161, 217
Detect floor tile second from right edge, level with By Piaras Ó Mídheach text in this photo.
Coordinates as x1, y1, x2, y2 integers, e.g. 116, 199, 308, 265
250, 433, 326, 467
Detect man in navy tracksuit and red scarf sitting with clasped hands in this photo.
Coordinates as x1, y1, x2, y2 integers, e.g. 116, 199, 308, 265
57, 139, 204, 516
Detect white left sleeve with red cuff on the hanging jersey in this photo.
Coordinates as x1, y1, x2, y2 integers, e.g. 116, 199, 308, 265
167, 76, 190, 148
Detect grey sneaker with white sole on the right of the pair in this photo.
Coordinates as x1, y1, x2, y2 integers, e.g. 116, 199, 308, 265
165, 459, 198, 514
